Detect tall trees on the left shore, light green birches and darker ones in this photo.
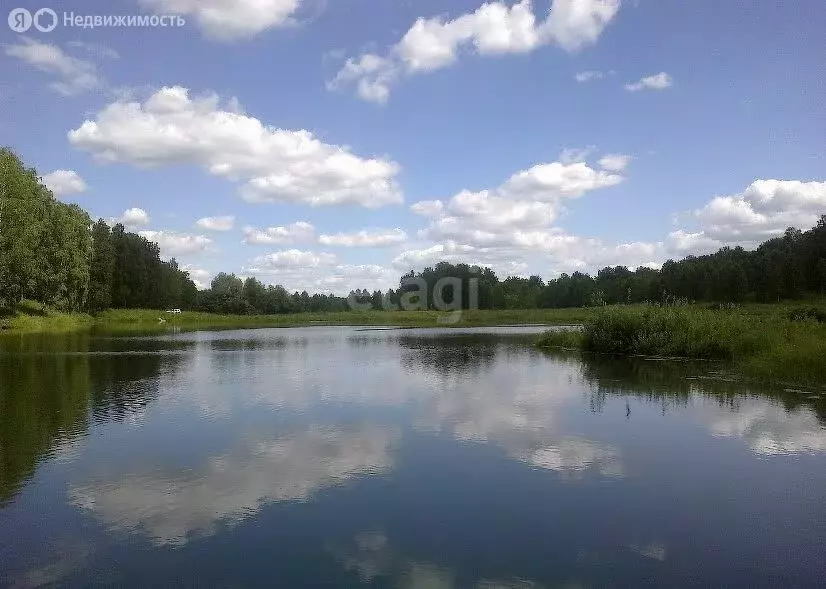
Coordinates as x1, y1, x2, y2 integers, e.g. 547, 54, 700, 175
0, 148, 197, 311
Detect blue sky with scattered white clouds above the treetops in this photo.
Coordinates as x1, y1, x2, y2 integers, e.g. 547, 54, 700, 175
0, 0, 826, 294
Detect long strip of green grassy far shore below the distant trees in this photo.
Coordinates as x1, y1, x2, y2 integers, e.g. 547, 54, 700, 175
0, 306, 593, 333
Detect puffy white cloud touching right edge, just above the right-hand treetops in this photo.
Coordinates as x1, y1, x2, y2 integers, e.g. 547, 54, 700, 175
668, 180, 826, 255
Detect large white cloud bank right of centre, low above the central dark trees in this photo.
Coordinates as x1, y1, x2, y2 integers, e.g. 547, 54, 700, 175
400, 155, 665, 276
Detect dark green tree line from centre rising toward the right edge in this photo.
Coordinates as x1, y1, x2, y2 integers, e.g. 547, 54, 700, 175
391, 220, 826, 309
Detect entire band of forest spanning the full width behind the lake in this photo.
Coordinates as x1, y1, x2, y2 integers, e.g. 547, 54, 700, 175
0, 148, 826, 314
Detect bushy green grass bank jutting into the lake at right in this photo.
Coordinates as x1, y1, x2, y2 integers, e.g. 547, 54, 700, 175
538, 305, 826, 385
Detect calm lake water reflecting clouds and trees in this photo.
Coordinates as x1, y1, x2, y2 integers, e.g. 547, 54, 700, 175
0, 327, 826, 587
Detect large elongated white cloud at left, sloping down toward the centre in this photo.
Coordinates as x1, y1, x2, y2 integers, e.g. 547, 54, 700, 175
68, 86, 403, 208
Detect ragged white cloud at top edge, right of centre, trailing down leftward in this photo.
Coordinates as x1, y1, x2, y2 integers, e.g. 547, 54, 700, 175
328, 0, 620, 103
